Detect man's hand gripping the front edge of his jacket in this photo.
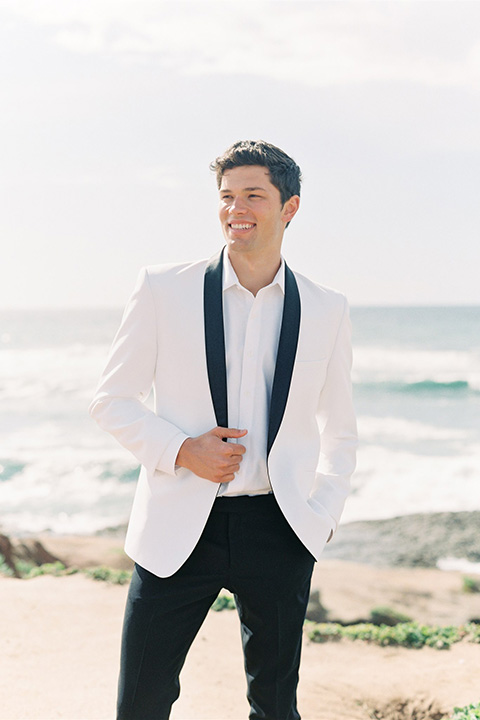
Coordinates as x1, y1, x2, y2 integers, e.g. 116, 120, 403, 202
175, 427, 248, 483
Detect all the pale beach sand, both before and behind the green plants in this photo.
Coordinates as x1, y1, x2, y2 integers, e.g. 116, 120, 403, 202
0, 516, 480, 720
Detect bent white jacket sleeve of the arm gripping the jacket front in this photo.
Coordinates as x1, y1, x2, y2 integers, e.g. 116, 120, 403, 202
89, 268, 188, 475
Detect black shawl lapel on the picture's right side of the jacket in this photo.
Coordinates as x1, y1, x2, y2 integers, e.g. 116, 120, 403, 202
267, 263, 300, 457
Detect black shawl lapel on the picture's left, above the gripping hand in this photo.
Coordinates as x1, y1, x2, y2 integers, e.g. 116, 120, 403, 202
203, 248, 228, 427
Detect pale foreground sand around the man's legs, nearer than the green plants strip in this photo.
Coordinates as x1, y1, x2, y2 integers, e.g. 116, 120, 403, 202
0, 571, 480, 720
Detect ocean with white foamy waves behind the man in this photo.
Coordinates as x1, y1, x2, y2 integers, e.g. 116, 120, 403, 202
0, 307, 480, 534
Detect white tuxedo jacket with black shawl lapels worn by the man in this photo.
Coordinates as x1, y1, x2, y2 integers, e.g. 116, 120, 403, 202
90, 253, 357, 577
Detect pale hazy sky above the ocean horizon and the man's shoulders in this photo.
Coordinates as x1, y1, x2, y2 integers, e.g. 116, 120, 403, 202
0, 0, 480, 309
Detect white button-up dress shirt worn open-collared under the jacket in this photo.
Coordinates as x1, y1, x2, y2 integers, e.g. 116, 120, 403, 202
219, 252, 285, 497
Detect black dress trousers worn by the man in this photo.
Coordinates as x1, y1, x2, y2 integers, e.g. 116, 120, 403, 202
117, 494, 315, 720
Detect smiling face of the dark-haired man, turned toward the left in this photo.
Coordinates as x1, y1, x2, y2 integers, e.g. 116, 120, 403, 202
219, 165, 298, 257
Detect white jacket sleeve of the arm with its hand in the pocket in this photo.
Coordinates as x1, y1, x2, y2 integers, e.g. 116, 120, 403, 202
309, 298, 358, 530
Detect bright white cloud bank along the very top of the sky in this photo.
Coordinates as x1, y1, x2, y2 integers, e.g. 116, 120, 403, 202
3, 0, 480, 89
